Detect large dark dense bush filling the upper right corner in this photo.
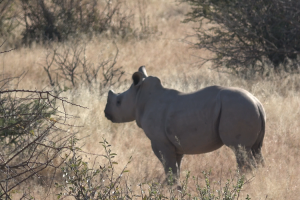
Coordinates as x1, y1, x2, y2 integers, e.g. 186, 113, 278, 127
182, 0, 300, 74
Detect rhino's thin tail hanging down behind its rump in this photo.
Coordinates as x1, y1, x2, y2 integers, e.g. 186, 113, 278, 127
251, 102, 266, 166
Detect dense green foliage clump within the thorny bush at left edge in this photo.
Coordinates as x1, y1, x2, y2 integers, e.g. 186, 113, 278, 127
0, 91, 55, 145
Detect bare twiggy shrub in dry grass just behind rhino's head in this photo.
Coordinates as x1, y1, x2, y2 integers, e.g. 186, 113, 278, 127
43, 42, 125, 94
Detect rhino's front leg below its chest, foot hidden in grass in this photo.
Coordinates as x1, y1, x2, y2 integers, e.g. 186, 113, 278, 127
151, 141, 182, 182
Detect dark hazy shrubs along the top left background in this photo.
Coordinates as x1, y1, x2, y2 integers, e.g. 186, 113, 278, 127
20, 0, 131, 43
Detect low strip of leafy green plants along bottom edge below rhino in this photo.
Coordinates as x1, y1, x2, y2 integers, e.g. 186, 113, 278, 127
135, 171, 251, 200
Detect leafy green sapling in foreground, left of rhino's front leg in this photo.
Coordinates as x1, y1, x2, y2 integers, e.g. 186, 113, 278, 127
56, 139, 131, 199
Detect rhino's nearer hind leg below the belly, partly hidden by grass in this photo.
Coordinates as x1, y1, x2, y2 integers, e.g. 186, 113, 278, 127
233, 146, 256, 173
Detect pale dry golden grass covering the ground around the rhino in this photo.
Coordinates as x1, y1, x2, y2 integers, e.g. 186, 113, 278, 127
0, 0, 300, 200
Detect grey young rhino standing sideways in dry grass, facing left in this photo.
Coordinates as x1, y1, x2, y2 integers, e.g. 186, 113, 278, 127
104, 66, 266, 179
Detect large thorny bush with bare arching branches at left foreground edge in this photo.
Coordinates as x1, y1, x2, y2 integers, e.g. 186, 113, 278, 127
0, 86, 84, 199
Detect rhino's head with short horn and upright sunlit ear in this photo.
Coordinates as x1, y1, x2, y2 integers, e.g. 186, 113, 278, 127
104, 66, 148, 123
